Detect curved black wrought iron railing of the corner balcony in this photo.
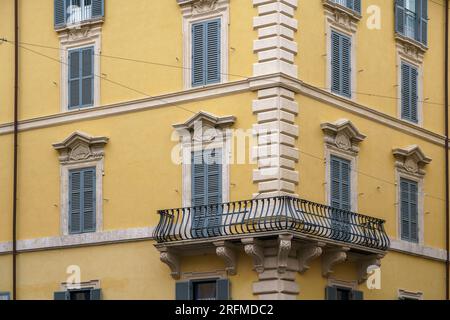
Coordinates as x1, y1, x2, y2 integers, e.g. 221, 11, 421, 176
154, 196, 390, 251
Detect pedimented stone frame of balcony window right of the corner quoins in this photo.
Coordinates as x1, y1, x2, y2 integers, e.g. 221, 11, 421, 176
321, 119, 366, 212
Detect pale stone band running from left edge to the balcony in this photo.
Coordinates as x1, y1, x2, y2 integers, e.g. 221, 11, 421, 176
0, 227, 155, 255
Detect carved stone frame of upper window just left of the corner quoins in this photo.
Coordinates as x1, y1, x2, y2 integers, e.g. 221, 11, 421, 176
177, 0, 230, 89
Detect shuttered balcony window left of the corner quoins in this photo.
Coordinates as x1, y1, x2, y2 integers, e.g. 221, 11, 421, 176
191, 149, 222, 237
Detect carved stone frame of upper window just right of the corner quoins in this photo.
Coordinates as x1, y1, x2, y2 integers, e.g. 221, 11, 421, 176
323, 0, 361, 101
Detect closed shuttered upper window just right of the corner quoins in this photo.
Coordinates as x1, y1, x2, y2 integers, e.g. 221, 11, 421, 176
331, 30, 352, 98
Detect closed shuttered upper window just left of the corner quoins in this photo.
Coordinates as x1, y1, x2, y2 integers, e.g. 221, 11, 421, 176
192, 19, 221, 87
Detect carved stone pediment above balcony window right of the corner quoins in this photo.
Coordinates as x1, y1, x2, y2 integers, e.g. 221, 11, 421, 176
321, 119, 366, 154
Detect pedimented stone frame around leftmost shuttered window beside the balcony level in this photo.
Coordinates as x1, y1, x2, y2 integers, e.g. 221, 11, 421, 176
53, 131, 109, 236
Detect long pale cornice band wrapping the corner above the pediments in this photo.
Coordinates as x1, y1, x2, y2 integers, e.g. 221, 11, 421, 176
0, 74, 445, 146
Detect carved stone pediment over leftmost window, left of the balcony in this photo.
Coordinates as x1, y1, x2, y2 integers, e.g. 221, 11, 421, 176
53, 131, 109, 164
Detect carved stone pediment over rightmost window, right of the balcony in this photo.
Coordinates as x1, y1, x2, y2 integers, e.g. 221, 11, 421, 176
392, 145, 432, 176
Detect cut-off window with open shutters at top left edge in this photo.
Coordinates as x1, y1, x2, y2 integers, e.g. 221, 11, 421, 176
54, 0, 104, 29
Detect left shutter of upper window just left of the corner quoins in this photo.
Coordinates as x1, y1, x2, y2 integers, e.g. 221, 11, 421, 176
192, 23, 206, 86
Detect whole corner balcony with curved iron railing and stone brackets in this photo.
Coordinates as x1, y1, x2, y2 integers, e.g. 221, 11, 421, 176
154, 196, 390, 281
